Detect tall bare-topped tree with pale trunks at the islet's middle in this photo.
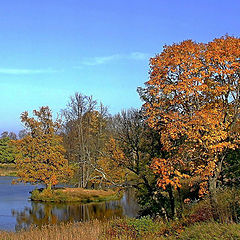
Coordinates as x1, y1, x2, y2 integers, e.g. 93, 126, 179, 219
62, 93, 111, 188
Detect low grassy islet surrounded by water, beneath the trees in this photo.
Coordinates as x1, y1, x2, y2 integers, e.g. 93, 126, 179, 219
31, 188, 122, 203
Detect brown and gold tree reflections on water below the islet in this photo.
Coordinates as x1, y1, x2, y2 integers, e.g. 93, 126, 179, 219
12, 191, 138, 231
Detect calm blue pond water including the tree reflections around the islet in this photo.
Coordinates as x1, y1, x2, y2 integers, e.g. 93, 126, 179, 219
0, 177, 139, 231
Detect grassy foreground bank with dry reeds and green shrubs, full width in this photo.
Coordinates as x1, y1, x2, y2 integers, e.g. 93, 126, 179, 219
0, 218, 240, 240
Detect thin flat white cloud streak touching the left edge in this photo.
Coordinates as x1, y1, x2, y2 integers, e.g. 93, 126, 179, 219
0, 68, 59, 75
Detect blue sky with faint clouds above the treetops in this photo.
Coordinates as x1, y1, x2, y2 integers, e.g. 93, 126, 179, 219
0, 0, 240, 132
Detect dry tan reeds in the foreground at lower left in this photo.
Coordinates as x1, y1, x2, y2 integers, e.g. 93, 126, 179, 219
0, 219, 163, 240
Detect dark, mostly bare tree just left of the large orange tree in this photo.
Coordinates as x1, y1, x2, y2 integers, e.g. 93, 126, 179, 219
108, 109, 157, 191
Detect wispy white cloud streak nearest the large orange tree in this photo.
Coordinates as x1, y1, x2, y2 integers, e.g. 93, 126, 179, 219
81, 52, 149, 66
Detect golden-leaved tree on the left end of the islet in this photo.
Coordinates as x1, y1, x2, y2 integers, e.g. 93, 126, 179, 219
15, 107, 72, 189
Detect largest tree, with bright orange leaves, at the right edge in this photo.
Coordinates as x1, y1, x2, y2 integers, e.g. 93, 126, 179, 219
140, 36, 240, 206
